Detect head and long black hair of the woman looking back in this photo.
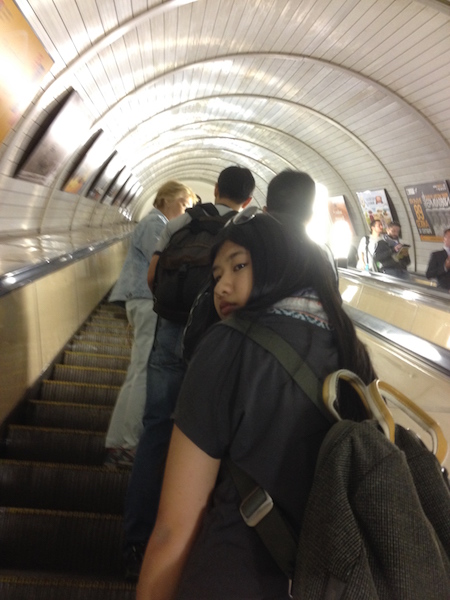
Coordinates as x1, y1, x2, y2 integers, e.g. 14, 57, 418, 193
211, 214, 374, 383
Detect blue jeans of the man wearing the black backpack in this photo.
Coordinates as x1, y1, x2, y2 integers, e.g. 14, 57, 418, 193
124, 317, 186, 552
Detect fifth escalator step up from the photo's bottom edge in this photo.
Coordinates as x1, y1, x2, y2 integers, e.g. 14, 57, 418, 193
25, 400, 112, 431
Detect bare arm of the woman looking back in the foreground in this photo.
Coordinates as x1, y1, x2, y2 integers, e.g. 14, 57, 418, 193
136, 425, 220, 600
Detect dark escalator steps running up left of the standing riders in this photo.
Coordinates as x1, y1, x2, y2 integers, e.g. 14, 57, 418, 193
0, 304, 135, 600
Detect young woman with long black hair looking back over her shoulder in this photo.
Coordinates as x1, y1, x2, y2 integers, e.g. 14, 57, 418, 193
137, 211, 375, 600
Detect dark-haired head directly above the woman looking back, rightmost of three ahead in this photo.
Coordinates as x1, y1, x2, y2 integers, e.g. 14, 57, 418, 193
266, 170, 316, 225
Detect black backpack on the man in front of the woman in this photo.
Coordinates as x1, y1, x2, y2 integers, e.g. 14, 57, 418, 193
154, 204, 236, 323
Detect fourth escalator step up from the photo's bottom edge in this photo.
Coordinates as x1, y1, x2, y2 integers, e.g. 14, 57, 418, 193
6, 425, 105, 465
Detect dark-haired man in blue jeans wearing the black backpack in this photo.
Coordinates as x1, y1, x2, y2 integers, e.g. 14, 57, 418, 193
124, 166, 255, 580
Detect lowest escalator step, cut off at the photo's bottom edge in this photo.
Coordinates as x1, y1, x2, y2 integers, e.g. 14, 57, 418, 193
0, 571, 136, 600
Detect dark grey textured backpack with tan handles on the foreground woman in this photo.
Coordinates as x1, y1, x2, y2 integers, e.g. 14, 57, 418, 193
221, 315, 450, 600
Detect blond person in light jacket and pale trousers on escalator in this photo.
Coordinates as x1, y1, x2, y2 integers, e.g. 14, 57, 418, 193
105, 181, 196, 466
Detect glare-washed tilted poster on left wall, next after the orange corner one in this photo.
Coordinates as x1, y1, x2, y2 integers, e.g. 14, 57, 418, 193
16, 90, 91, 186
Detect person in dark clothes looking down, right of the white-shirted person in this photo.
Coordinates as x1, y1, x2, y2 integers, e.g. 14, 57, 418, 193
374, 221, 411, 279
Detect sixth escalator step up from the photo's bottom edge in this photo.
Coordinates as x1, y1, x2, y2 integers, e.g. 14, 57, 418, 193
41, 379, 120, 406
